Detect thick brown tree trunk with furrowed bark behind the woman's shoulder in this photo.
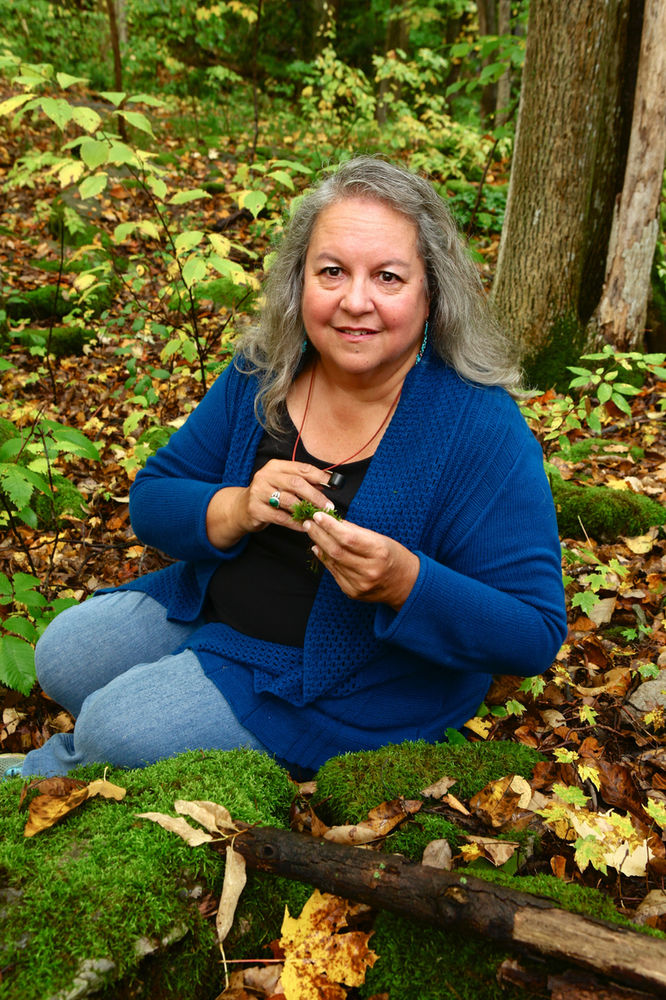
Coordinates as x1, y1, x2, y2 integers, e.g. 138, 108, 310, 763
493, 0, 642, 354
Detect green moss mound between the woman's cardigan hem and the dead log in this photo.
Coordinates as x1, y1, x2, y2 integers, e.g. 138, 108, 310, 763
317, 740, 543, 823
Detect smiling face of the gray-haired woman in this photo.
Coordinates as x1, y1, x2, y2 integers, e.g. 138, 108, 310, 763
301, 198, 429, 384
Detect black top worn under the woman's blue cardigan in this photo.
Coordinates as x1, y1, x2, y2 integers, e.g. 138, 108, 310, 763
205, 416, 371, 646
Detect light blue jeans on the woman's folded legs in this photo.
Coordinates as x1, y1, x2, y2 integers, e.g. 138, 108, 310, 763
22, 590, 265, 777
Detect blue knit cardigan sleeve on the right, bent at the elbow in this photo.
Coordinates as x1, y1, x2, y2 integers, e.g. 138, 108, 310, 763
375, 410, 566, 676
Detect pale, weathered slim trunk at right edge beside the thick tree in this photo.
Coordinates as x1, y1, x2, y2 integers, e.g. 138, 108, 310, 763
592, 0, 666, 350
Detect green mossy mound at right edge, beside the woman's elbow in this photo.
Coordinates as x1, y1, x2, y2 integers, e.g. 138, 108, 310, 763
550, 474, 666, 542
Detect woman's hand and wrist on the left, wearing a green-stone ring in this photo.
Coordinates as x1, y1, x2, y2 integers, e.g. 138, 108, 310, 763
206, 458, 333, 549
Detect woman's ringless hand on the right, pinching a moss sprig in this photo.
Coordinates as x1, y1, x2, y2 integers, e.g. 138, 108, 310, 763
304, 513, 420, 611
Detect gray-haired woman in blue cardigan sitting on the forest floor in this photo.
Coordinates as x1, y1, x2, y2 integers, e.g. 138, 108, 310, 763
3, 157, 566, 776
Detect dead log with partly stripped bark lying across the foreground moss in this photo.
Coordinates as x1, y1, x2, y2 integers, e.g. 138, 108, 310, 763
211, 827, 666, 997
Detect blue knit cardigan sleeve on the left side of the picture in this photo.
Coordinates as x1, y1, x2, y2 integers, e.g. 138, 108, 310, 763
130, 364, 252, 561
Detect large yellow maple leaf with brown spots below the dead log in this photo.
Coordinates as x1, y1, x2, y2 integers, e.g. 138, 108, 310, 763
280, 889, 377, 1000
